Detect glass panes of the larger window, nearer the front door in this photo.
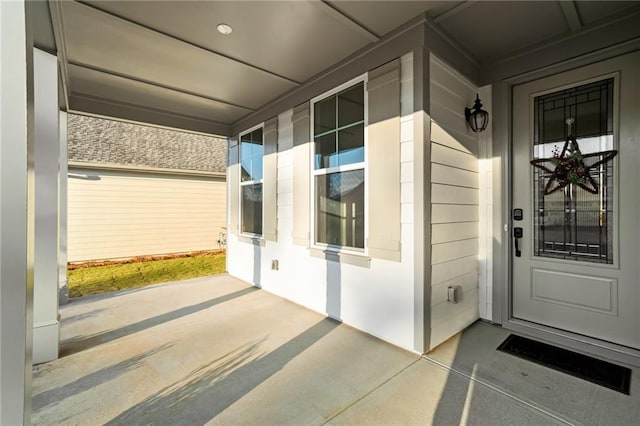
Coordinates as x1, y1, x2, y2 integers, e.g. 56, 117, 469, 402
313, 81, 365, 249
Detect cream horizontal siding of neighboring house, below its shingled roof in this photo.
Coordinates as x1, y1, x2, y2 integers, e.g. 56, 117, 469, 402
68, 168, 226, 262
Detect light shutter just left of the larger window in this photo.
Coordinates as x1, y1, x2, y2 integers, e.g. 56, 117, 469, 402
292, 102, 311, 247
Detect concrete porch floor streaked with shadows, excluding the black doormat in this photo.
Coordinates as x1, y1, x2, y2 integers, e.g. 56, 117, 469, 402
32, 275, 640, 425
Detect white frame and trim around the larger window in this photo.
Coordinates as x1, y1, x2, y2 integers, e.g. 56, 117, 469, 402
309, 73, 369, 256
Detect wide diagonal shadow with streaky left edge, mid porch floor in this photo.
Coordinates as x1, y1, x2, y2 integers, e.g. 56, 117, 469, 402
107, 319, 340, 425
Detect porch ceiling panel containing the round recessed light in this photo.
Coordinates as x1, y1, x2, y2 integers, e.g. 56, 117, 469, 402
75, 1, 376, 82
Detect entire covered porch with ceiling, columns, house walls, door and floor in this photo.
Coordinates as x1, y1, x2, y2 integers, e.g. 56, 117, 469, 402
0, 1, 640, 424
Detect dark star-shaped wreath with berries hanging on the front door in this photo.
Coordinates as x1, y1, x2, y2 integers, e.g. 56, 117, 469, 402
531, 136, 618, 195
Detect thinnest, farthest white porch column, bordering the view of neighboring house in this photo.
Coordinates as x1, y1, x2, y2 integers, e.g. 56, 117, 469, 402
58, 111, 69, 305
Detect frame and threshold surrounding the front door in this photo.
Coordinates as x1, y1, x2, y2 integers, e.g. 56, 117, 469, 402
492, 41, 640, 366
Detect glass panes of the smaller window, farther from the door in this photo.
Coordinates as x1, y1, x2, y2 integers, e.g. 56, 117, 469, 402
240, 127, 264, 235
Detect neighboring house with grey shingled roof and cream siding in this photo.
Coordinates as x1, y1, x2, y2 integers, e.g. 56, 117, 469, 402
68, 114, 226, 262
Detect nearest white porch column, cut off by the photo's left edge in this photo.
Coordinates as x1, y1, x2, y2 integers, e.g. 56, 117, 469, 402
0, 1, 33, 425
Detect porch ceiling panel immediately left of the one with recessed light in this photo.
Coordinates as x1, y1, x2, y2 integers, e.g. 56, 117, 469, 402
63, 2, 295, 109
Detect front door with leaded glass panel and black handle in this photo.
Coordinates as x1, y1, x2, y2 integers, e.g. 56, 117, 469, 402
511, 52, 640, 349
